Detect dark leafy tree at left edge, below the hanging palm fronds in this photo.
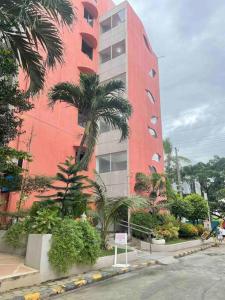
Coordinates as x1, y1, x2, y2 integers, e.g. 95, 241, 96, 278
0, 48, 33, 147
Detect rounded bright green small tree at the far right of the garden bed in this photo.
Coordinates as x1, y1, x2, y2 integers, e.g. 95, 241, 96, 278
184, 194, 208, 223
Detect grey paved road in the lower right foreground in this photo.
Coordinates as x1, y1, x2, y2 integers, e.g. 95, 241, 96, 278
58, 246, 225, 300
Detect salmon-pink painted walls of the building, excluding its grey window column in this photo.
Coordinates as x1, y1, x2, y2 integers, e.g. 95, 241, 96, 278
4, 0, 164, 210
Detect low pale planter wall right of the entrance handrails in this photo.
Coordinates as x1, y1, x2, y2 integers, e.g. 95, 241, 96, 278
141, 238, 213, 252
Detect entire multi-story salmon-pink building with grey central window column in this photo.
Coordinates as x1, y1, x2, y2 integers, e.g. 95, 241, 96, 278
7, 0, 164, 210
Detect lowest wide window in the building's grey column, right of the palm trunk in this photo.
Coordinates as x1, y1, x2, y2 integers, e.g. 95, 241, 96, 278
97, 151, 127, 173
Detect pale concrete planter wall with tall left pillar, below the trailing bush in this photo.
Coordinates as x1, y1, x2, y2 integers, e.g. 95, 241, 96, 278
25, 234, 137, 282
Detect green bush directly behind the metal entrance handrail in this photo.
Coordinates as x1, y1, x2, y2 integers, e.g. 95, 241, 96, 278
130, 211, 159, 239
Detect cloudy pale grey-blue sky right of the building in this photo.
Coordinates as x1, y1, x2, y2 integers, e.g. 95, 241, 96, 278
115, 0, 225, 162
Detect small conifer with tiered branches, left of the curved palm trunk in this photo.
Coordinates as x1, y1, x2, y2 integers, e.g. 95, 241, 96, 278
39, 157, 88, 217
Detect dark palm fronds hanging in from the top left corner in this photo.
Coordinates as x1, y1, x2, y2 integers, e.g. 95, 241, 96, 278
0, 0, 75, 94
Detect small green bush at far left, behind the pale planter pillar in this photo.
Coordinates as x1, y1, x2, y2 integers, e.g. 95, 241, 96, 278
4, 221, 28, 248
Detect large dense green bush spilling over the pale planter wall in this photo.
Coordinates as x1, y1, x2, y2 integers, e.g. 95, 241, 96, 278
49, 219, 100, 273
